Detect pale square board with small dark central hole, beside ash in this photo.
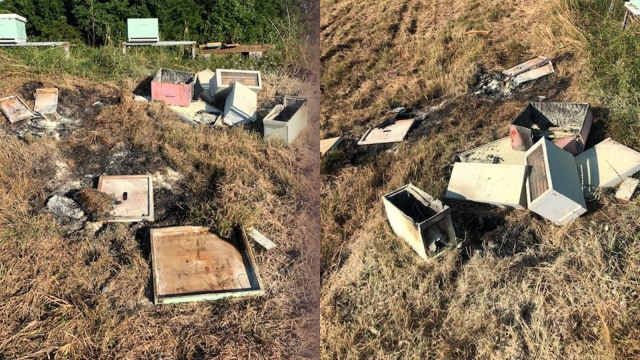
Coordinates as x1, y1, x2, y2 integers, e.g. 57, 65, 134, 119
98, 175, 154, 222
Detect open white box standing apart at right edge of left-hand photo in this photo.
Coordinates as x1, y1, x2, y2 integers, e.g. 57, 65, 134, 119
263, 96, 309, 144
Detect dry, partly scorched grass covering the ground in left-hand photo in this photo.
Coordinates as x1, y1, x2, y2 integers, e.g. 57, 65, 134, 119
0, 35, 319, 359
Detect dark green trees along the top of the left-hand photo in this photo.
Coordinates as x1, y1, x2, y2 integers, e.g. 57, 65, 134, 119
0, 0, 307, 46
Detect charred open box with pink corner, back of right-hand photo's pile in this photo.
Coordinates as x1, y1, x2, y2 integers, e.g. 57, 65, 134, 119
509, 102, 593, 155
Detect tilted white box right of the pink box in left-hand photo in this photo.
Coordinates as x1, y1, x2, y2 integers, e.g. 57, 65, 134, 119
222, 82, 258, 126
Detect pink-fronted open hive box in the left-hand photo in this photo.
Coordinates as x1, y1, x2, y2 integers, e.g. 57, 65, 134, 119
151, 69, 195, 106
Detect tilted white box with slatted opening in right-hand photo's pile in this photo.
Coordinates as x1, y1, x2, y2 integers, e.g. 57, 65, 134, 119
525, 138, 587, 225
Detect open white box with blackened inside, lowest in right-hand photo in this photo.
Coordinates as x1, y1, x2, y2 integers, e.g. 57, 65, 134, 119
382, 184, 457, 260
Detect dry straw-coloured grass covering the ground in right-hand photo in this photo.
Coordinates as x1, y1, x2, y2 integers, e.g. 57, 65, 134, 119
320, 0, 640, 359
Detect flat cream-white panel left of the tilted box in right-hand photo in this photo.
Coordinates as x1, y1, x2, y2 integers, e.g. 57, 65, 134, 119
445, 162, 527, 209
